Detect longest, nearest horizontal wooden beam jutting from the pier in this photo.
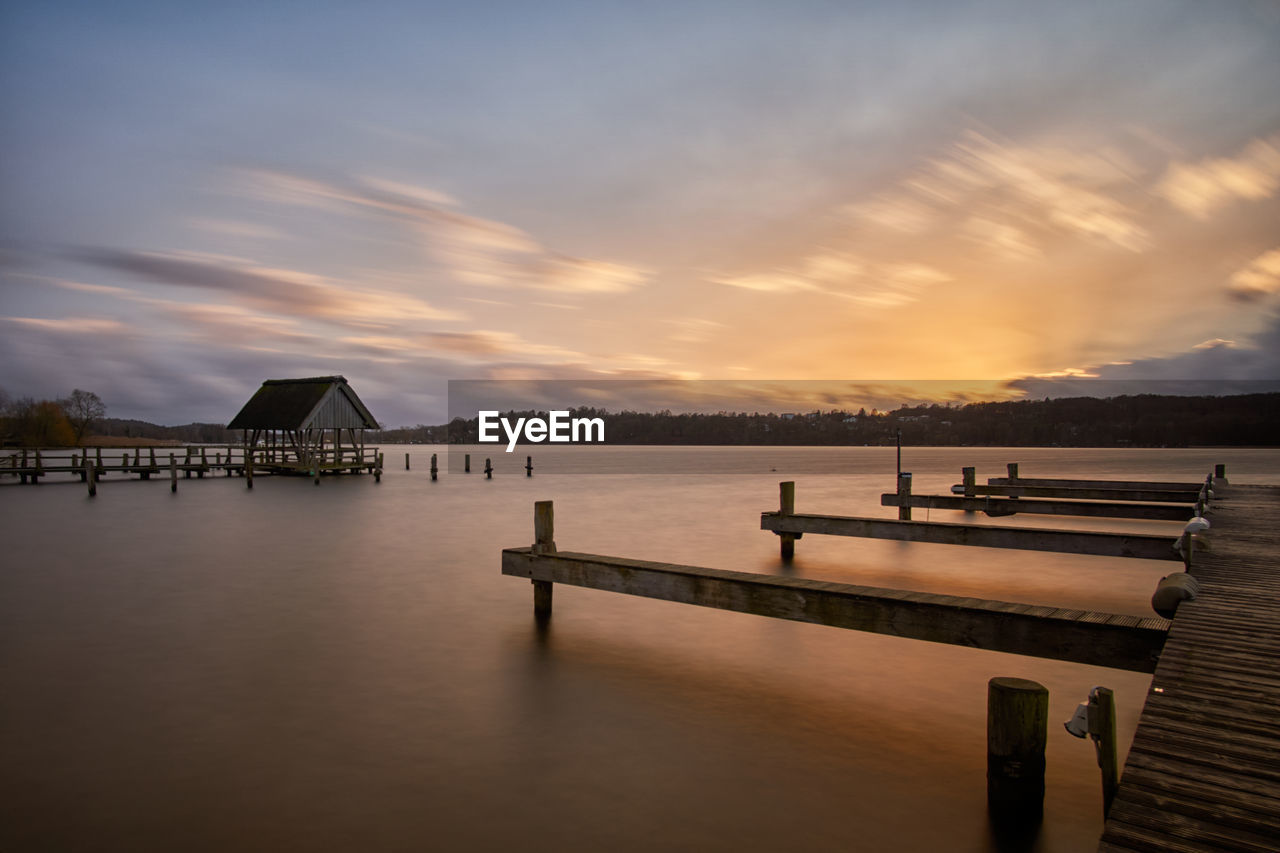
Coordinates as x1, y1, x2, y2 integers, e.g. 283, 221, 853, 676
502, 548, 1170, 672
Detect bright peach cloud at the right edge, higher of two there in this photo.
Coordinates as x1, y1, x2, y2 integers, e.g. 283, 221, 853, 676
1156, 134, 1280, 219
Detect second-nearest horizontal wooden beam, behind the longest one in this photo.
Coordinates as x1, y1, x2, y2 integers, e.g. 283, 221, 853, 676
760, 512, 1181, 560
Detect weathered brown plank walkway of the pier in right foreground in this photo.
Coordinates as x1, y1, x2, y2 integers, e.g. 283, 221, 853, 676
1100, 485, 1280, 852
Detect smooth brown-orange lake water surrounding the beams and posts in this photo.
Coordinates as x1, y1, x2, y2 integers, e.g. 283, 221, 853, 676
0, 447, 1280, 852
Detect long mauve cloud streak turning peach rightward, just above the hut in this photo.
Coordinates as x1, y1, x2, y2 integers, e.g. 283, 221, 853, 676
74, 248, 461, 323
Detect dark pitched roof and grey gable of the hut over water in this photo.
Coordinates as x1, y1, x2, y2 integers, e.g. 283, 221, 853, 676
227, 377, 378, 429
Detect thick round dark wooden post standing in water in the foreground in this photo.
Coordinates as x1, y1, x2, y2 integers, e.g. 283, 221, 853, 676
987, 678, 1048, 822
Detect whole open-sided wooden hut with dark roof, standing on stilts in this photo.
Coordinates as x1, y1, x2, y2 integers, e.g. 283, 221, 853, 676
227, 377, 378, 470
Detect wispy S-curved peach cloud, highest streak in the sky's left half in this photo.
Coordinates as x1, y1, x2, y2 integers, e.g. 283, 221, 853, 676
235, 169, 652, 293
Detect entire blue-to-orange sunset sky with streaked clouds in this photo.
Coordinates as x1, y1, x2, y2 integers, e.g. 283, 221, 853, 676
0, 0, 1280, 427
